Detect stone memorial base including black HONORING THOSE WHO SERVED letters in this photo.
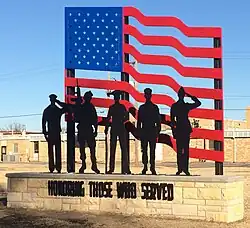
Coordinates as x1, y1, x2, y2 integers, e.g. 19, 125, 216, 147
6, 173, 244, 223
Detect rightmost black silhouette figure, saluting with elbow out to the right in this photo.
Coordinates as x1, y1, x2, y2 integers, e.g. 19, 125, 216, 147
170, 87, 201, 176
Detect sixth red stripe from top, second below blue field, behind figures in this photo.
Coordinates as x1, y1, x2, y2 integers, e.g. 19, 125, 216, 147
67, 96, 224, 141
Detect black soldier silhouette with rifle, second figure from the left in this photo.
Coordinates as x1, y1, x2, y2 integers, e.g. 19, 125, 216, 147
75, 91, 100, 174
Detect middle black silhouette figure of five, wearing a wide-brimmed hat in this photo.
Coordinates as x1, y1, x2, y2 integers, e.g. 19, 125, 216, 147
105, 90, 131, 174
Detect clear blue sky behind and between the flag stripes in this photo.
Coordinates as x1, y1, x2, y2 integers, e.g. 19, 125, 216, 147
0, 0, 250, 130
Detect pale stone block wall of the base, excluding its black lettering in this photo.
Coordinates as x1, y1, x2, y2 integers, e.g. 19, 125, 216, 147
7, 173, 244, 223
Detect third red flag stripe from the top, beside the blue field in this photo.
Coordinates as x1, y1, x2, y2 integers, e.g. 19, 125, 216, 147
123, 43, 222, 79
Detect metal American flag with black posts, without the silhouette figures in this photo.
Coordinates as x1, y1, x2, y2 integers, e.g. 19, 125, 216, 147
65, 7, 224, 174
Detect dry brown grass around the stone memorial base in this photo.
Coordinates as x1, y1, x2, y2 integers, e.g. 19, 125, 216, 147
0, 164, 250, 228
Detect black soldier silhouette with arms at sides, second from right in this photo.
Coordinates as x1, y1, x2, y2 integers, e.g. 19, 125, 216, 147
137, 88, 161, 175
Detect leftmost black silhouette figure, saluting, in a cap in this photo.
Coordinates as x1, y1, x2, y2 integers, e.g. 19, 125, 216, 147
42, 94, 67, 173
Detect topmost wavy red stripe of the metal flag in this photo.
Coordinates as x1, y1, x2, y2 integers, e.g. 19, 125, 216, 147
123, 7, 222, 38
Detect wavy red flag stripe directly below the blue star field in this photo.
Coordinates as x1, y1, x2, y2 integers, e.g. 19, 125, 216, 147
65, 78, 223, 120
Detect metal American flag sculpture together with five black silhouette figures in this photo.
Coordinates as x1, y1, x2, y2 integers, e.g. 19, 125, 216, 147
43, 7, 224, 175
